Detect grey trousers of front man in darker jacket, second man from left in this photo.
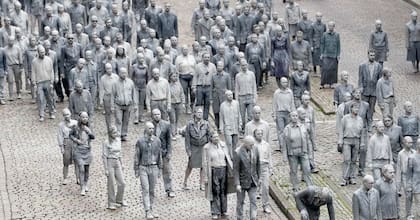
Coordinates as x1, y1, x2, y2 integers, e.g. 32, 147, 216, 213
140, 165, 159, 212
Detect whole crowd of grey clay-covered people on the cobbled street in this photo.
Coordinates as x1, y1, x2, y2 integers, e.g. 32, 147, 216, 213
4, 0, 420, 219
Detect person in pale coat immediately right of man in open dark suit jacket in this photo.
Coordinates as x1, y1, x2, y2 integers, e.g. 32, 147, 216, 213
376, 68, 397, 116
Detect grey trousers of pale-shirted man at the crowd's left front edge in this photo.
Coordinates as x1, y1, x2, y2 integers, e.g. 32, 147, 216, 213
37, 81, 55, 117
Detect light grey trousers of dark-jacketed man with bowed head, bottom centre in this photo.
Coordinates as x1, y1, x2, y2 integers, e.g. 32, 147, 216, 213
236, 186, 257, 220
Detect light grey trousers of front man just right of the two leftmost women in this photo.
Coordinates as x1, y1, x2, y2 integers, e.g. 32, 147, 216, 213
107, 158, 125, 206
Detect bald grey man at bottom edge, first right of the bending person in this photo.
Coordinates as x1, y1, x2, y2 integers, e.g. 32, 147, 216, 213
352, 175, 382, 220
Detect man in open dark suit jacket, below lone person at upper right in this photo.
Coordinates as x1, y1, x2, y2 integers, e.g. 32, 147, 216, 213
358, 50, 382, 126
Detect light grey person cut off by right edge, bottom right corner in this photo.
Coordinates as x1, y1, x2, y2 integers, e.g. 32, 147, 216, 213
407, 140, 420, 219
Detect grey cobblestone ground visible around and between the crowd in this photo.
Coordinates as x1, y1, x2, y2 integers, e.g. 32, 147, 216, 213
0, 0, 420, 219
